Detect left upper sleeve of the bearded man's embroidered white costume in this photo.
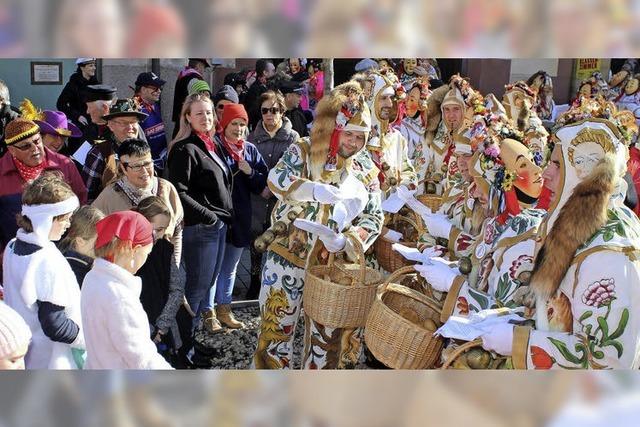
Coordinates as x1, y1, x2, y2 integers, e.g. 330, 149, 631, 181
267, 142, 314, 202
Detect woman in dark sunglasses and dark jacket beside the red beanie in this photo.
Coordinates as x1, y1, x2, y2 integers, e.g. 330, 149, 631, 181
247, 90, 300, 299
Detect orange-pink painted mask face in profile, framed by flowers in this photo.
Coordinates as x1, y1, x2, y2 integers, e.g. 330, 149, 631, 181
500, 139, 542, 198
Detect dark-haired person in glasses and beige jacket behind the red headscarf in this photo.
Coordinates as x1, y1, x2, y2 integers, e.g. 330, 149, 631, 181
92, 138, 184, 266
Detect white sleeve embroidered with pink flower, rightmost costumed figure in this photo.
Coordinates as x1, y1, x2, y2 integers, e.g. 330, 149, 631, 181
512, 251, 640, 369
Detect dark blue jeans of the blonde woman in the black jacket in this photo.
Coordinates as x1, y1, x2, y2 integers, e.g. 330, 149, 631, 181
182, 221, 227, 325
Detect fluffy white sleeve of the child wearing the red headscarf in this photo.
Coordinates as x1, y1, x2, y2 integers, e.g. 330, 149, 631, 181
105, 292, 172, 369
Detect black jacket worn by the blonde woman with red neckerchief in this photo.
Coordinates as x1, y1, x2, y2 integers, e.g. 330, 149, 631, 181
168, 134, 233, 226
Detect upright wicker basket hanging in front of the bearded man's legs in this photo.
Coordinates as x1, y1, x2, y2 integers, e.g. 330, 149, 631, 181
303, 245, 382, 328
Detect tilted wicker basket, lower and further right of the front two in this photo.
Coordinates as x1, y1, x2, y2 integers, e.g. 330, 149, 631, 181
364, 267, 443, 369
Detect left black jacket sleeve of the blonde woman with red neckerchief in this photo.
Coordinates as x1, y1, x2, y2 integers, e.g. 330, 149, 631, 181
169, 146, 218, 224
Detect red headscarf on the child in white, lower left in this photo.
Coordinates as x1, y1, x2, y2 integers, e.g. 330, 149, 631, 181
95, 211, 153, 249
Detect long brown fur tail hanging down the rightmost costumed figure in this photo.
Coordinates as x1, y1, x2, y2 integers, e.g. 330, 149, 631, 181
531, 155, 618, 301
